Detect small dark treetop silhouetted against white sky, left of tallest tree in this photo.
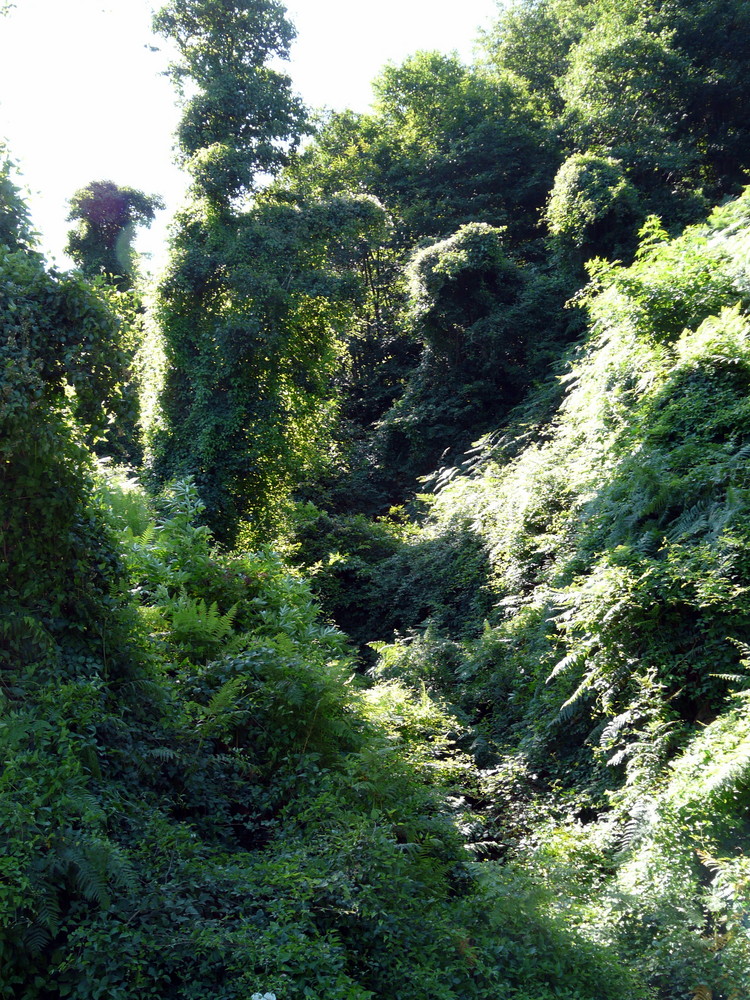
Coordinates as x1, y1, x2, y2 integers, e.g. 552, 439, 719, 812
65, 181, 164, 289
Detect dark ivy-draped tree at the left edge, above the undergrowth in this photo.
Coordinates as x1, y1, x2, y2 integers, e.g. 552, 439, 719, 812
0, 154, 134, 691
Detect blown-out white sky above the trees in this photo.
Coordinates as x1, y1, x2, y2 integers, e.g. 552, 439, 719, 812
0, 0, 506, 266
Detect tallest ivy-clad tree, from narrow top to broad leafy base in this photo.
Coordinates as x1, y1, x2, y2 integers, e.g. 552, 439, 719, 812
153, 0, 383, 542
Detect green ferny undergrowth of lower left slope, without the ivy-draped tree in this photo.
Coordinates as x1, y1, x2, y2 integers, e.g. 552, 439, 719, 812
0, 450, 648, 1000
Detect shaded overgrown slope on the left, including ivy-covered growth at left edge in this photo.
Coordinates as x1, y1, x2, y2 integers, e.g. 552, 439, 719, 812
0, 160, 633, 1000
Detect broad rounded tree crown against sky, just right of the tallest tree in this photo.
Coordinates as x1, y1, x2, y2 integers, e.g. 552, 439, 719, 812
290, 52, 558, 252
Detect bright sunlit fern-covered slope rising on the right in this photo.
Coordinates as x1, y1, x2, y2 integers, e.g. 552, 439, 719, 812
368, 194, 750, 1000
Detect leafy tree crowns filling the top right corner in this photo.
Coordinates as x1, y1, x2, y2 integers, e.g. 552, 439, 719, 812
485, 0, 750, 227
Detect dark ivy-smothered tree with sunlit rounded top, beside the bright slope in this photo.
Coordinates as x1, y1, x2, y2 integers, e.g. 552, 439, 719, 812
377, 223, 548, 490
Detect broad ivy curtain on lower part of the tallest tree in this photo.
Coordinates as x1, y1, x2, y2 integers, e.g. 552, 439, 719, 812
154, 198, 388, 542
